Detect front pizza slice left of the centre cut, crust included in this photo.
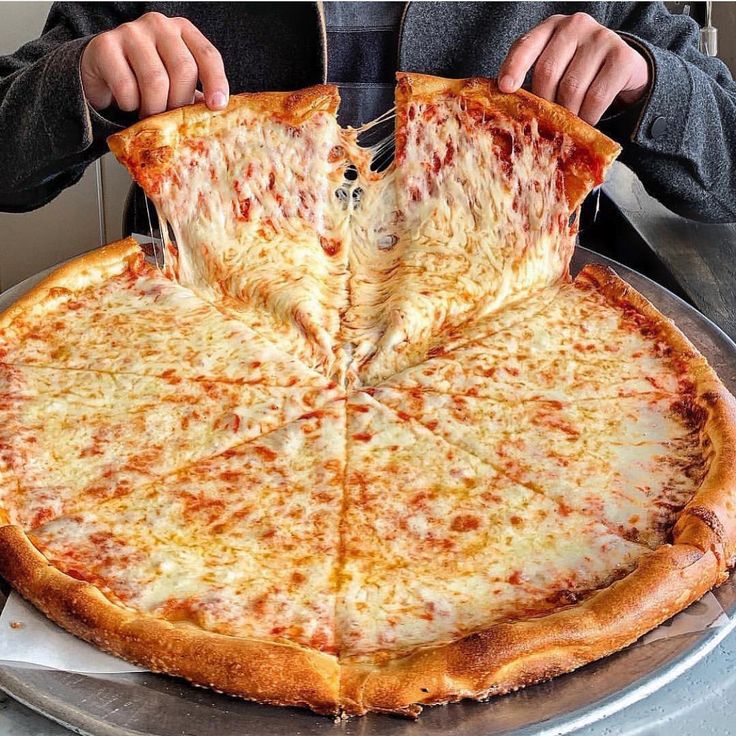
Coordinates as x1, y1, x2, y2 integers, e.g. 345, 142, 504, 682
5, 401, 345, 712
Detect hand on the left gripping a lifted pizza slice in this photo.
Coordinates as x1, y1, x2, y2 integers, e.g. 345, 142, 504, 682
80, 13, 229, 118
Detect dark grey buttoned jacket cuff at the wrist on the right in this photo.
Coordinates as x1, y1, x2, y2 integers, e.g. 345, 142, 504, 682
619, 32, 692, 154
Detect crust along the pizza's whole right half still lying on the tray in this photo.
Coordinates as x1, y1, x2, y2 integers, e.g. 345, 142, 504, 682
341, 265, 736, 716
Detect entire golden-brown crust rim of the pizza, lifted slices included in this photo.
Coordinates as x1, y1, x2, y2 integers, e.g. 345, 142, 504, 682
0, 79, 736, 716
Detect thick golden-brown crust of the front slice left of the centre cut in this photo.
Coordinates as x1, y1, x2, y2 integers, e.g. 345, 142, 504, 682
0, 526, 339, 714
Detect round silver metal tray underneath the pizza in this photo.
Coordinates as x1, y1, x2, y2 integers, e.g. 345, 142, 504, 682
0, 248, 736, 736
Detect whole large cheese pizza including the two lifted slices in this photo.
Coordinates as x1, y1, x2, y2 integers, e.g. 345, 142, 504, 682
0, 74, 736, 717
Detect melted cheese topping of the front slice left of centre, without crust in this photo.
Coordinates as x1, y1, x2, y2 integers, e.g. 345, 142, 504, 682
33, 401, 345, 651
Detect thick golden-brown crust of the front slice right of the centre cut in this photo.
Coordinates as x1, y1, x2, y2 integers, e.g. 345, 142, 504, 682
341, 545, 723, 716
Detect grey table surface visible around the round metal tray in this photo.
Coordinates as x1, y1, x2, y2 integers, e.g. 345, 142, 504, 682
0, 167, 736, 736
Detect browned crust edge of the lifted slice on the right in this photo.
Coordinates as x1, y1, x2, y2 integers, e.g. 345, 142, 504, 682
396, 72, 621, 210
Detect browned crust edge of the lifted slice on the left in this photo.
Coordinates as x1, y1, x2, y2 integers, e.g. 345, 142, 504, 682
107, 84, 340, 194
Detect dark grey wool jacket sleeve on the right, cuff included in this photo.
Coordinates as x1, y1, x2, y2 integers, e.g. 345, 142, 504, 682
600, 3, 736, 222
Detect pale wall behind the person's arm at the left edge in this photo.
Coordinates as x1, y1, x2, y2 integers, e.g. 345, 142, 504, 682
0, 2, 130, 290
